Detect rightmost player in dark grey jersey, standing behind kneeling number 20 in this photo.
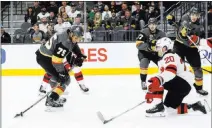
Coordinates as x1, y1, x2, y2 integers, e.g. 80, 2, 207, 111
167, 8, 208, 95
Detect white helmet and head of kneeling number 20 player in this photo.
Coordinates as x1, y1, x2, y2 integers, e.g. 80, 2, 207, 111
156, 37, 174, 57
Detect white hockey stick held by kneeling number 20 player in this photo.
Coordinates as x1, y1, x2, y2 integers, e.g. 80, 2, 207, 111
97, 101, 146, 124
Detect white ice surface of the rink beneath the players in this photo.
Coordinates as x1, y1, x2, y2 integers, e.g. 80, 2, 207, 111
2, 75, 211, 128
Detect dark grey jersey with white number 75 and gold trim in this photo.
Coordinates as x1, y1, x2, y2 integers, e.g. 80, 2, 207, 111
39, 32, 77, 72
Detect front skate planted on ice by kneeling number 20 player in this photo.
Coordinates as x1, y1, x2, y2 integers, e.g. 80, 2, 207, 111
146, 102, 165, 117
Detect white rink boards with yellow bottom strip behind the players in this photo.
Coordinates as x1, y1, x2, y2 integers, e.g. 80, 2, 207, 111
1, 40, 212, 76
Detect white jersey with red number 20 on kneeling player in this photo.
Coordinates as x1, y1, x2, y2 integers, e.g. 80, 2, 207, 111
158, 53, 192, 84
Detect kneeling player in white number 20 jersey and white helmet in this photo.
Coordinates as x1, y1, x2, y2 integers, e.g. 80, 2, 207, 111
145, 37, 207, 117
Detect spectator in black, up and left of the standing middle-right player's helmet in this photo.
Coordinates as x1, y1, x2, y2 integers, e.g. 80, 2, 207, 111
132, 2, 146, 30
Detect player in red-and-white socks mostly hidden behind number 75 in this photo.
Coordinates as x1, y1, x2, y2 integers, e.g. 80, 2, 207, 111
39, 44, 89, 95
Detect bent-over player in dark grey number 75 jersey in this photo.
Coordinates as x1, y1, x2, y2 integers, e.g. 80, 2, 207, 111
36, 27, 82, 107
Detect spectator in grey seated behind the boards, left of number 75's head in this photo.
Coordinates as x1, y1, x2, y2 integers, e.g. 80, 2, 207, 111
30, 24, 46, 43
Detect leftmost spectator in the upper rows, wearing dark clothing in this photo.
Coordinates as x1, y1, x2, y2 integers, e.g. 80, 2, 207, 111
24, 7, 37, 25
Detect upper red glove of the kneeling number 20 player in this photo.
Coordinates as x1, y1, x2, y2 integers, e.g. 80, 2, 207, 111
148, 77, 163, 92
